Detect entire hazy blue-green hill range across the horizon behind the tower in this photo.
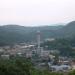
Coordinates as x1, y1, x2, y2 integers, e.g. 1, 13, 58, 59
0, 21, 75, 45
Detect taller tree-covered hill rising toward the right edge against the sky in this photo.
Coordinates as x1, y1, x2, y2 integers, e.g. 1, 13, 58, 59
57, 21, 75, 37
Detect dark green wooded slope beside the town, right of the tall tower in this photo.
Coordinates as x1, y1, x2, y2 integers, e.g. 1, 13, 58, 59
41, 38, 75, 57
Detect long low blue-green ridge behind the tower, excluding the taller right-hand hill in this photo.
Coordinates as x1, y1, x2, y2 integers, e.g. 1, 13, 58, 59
0, 25, 63, 45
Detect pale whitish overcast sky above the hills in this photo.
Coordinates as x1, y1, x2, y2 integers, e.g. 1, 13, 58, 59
0, 0, 75, 26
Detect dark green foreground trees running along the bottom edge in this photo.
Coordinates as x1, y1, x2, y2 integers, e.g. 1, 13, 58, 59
0, 59, 75, 75
